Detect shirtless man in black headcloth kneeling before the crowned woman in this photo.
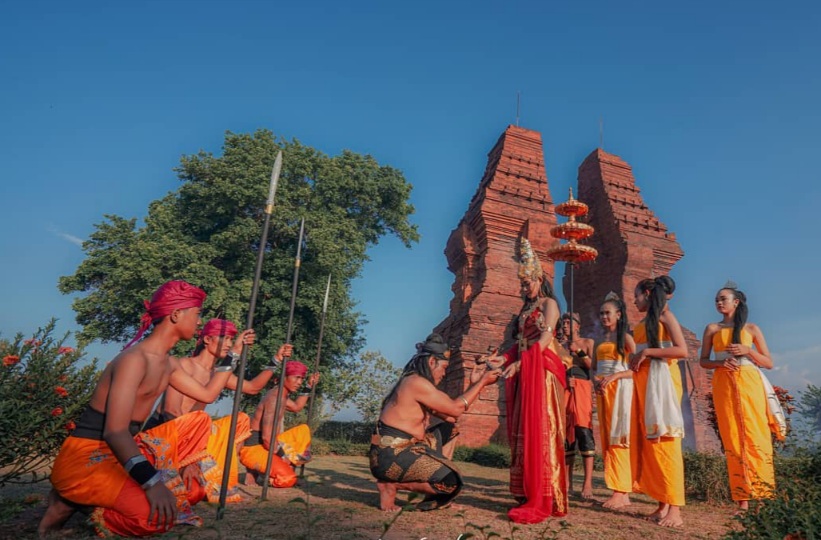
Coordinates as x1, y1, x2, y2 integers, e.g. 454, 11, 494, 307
369, 334, 499, 512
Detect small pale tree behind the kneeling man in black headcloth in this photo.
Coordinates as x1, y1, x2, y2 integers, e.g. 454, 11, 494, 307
333, 351, 402, 423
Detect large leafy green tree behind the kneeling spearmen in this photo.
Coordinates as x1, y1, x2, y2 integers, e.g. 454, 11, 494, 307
59, 130, 419, 404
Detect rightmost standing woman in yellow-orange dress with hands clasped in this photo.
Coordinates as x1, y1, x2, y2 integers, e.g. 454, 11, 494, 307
700, 282, 786, 511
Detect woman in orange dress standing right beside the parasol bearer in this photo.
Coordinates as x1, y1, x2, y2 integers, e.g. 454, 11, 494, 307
593, 292, 636, 509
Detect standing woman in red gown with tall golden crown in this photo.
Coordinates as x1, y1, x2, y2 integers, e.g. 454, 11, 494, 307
488, 238, 567, 523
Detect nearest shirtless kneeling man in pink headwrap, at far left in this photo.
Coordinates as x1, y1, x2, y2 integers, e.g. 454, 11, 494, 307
38, 281, 239, 536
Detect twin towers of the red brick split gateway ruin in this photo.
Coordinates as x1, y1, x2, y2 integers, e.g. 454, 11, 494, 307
435, 126, 719, 451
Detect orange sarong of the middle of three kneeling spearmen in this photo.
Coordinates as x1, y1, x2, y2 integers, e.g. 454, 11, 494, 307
205, 412, 251, 502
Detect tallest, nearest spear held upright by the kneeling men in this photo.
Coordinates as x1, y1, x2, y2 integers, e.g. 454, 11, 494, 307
217, 150, 282, 520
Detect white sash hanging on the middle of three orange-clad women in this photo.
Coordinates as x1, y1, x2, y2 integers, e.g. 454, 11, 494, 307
636, 341, 684, 439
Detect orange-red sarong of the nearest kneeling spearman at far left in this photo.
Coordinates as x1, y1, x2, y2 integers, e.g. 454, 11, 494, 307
51, 411, 211, 536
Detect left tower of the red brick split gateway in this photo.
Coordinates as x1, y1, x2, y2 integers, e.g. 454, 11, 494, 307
436, 126, 556, 446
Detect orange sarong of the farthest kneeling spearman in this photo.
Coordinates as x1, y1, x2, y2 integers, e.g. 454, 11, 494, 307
239, 424, 311, 488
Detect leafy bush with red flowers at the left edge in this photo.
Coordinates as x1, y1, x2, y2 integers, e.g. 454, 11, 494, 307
0, 319, 99, 486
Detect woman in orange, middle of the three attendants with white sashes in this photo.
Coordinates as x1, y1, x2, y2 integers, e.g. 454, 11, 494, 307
630, 276, 687, 527
